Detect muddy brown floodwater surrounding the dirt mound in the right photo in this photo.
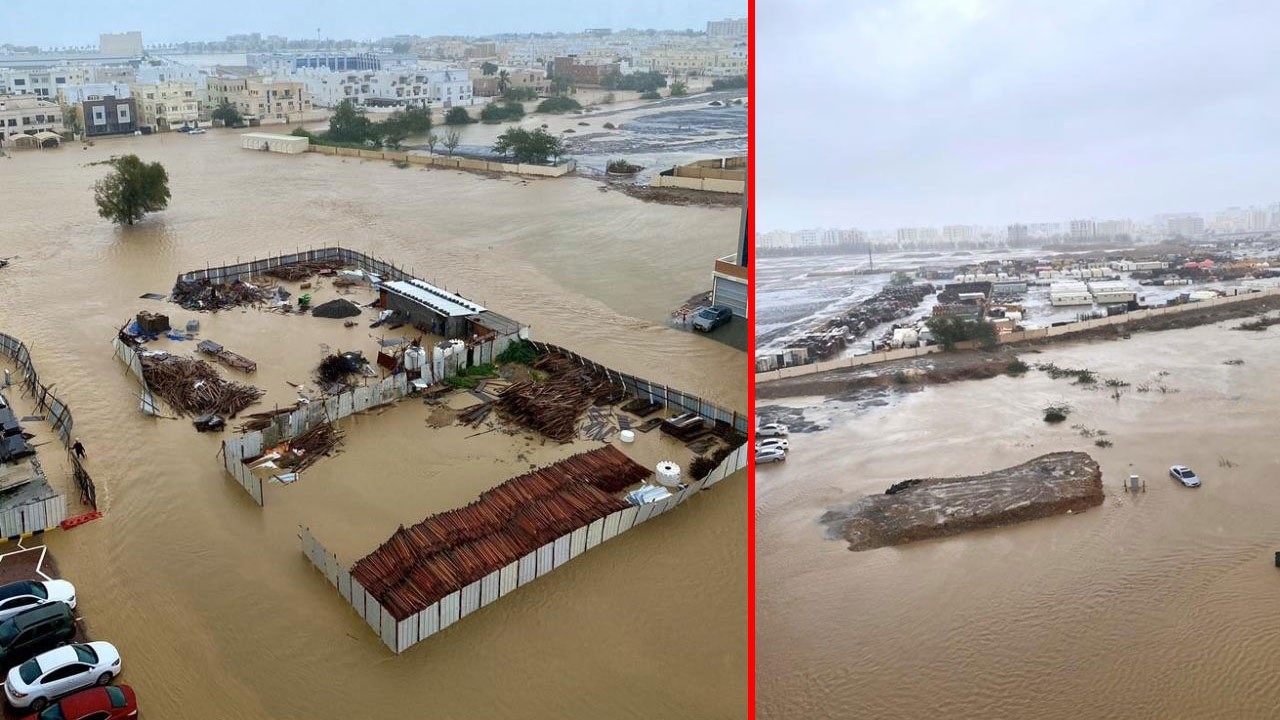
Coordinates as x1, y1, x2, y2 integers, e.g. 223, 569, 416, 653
756, 320, 1280, 720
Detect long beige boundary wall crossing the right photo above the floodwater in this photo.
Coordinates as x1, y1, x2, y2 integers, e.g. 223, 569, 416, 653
755, 288, 1280, 383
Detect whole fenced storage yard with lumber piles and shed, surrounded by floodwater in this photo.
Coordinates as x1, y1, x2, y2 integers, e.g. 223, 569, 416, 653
113, 249, 748, 652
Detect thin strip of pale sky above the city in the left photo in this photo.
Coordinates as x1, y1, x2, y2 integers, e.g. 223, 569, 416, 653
0, 0, 746, 47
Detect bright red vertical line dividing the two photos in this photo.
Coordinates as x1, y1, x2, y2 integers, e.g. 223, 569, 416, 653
746, 0, 759, 719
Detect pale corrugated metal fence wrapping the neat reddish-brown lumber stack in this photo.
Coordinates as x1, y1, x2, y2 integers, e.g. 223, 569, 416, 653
301, 445, 750, 652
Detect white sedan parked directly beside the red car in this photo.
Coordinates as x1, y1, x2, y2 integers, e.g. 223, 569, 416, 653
4, 642, 120, 712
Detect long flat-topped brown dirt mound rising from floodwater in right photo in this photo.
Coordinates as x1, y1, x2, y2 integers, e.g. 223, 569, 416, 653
822, 452, 1102, 550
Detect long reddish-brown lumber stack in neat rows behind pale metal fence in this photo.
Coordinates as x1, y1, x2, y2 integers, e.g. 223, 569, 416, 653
351, 446, 650, 620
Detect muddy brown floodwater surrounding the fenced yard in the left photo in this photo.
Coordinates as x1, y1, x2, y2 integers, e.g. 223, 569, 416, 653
0, 132, 746, 719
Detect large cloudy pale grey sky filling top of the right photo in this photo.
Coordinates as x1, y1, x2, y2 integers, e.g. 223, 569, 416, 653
753, 0, 1280, 231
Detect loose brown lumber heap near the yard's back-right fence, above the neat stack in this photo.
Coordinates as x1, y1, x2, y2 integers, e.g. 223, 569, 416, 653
498, 352, 618, 442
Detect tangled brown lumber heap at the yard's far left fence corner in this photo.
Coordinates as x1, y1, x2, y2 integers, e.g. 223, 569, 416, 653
142, 355, 265, 418
